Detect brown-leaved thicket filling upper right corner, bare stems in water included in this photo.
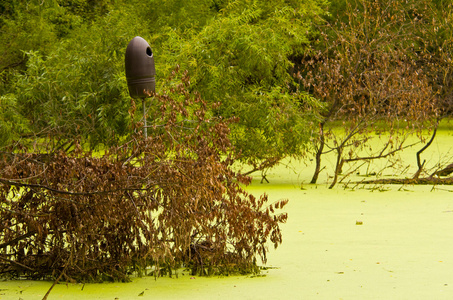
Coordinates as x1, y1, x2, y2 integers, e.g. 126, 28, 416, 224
294, 0, 453, 187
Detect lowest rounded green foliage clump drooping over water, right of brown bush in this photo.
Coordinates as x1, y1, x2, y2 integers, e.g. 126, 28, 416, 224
229, 88, 320, 167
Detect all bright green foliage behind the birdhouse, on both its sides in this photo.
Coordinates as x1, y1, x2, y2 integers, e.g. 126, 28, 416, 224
0, 0, 326, 164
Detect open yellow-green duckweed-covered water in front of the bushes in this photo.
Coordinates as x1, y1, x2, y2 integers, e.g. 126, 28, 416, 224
0, 136, 453, 300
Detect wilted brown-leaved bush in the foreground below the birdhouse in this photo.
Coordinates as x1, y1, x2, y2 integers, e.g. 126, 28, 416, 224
0, 72, 287, 281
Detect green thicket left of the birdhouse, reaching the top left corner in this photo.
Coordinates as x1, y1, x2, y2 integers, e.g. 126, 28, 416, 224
0, 1, 145, 149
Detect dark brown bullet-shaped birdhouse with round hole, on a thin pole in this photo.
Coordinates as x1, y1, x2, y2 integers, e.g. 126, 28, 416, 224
125, 36, 156, 98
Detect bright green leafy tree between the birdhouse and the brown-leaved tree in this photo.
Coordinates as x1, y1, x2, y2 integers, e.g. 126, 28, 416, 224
153, 0, 325, 170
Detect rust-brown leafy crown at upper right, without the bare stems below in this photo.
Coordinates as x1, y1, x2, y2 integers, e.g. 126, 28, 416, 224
298, 0, 441, 126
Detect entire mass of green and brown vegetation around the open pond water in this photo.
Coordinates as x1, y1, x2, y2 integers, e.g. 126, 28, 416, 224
0, 0, 453, 292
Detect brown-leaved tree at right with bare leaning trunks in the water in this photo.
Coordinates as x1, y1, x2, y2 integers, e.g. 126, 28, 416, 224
297, 0, 439, 187
